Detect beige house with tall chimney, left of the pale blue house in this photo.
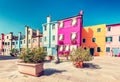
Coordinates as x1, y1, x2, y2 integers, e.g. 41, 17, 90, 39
24, 26, 42, 48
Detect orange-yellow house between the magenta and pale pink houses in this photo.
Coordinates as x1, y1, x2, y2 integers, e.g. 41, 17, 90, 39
82, 24, 106, 56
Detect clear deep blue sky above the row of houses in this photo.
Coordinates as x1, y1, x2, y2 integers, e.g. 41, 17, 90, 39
0, 0, 120, 34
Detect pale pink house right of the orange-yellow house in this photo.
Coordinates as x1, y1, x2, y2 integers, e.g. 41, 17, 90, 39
106, 24, 120, 56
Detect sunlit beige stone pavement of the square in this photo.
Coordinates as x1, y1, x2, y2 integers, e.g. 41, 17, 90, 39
0, 56, 120, 82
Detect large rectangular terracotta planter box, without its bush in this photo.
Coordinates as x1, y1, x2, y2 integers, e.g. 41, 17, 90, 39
17, 62, 43, 77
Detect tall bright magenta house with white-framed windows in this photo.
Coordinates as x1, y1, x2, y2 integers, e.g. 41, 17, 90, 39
58, 11, 83, 55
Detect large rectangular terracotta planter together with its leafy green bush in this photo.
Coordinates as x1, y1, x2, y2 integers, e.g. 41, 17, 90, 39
17, 48, 46, 76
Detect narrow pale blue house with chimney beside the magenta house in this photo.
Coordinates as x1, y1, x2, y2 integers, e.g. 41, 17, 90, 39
42, 16, 58, 56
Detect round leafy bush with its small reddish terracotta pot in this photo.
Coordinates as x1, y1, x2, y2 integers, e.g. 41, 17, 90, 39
70, 47, 92, 68
